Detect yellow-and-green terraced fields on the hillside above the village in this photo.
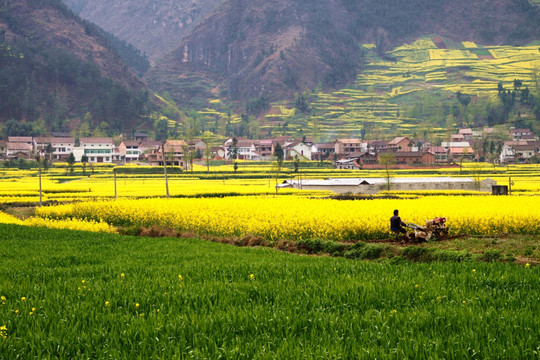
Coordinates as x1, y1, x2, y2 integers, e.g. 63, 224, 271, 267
189, 36, 540, 141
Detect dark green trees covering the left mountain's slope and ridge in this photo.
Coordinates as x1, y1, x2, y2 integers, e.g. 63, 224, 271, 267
0, 0, 150, 135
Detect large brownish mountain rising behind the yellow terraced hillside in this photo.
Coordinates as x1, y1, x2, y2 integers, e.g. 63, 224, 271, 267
145, 0, 540, 108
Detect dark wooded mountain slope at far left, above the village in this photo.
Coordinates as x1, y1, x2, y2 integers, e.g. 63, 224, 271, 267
0, 0, 149, 135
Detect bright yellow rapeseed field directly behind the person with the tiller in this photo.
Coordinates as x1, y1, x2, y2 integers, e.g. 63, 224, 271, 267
36, 196, 540, 241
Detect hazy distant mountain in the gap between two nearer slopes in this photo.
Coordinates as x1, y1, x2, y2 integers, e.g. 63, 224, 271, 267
64, 0, 221, 61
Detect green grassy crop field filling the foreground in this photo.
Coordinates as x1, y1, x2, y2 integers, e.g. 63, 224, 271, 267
0, 225, 540, 359
